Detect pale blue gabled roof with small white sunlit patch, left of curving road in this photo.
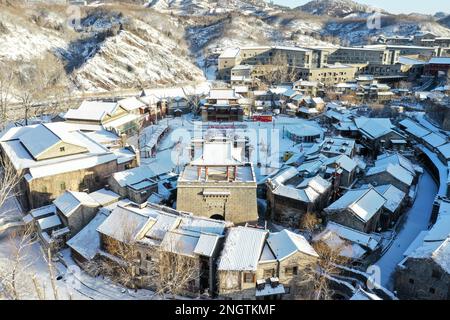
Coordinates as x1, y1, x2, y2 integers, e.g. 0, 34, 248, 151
325, 188, 386, 222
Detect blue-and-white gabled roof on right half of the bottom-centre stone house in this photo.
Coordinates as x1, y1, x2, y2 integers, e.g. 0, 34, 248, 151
267, 229, 319, 261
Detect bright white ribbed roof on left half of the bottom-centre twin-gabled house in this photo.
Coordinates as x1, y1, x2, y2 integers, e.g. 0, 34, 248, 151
218, 226, 268, 271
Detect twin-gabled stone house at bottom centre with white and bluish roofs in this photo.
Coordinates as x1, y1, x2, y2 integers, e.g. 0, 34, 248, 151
217, 227, 318, 300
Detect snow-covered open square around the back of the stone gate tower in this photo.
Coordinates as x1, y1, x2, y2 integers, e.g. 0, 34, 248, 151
137, 115, 319, 181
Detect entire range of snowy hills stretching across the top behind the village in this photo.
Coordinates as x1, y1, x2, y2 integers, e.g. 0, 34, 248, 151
0, 0, 450, 91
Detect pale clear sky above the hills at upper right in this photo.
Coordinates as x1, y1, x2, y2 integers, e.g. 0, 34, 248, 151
267, 0, 450, 14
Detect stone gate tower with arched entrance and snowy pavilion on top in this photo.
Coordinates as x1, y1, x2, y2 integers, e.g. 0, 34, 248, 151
177, 138, 258, 224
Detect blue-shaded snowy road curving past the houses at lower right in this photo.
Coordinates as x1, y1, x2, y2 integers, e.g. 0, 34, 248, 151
376, 170, 438, 290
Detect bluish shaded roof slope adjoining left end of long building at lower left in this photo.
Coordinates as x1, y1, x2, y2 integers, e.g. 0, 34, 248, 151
67, 213, 107, 260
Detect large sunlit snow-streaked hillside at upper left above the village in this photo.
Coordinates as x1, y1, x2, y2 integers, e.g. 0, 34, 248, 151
0, 8, 204, 91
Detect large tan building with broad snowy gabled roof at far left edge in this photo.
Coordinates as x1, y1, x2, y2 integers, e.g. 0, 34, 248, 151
0, 122, 135, 209
